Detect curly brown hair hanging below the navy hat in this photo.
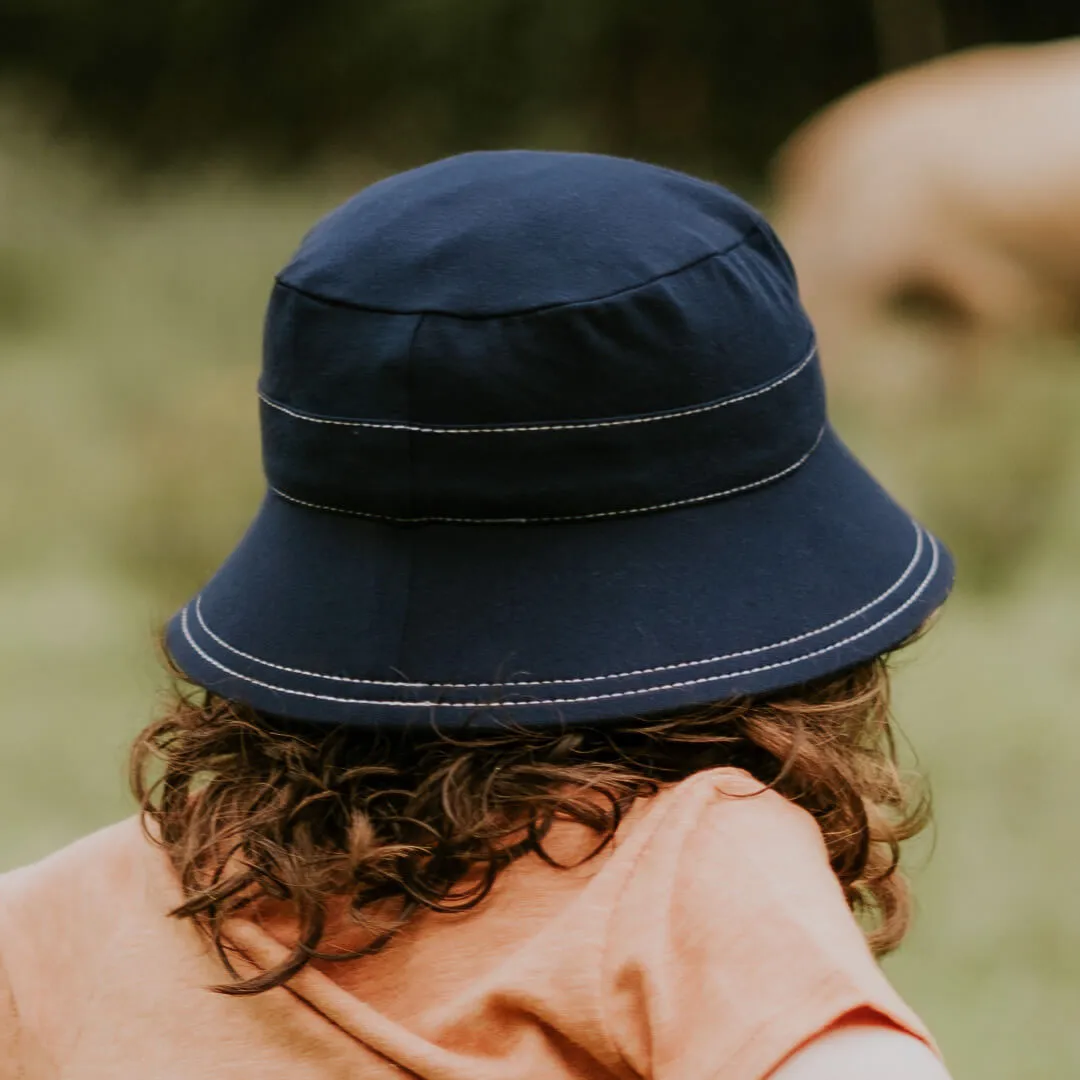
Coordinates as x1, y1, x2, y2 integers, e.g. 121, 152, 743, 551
131, 657, 929, 994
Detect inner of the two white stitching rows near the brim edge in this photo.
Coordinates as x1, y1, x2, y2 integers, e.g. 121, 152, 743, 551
194, 522, 924, 690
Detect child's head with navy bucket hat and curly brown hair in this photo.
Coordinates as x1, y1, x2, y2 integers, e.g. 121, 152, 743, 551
135, 152, 951, 988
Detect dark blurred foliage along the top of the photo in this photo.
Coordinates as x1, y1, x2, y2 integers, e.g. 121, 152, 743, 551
0, 0, 1080, 177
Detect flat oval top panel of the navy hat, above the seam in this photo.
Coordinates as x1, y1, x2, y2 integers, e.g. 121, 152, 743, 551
281, 150, 759, 318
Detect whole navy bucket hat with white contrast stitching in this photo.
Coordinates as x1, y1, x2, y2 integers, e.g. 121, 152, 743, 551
167, 151, 953, 728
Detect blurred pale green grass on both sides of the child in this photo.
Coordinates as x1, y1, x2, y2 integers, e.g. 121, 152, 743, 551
0, 130, 1080, 1080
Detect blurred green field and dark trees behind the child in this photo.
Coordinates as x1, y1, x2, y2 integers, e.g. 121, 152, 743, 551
0, 0, 1080, 1080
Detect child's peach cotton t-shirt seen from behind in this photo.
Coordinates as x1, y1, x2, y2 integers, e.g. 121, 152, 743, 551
0, 770, 929, 1080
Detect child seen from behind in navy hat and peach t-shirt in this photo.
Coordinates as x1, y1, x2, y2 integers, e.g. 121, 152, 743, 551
0, 152, 951, 1080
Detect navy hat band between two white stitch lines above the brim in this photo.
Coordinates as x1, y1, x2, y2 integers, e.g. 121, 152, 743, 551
261, 351, 825, 523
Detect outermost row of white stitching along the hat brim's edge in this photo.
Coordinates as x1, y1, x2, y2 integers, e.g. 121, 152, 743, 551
180, 536, 939, 708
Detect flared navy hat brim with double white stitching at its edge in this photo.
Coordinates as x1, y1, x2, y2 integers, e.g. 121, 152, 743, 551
166, 429, 953, 728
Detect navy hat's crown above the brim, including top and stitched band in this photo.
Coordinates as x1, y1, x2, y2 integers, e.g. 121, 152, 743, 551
261, 151, 824, 519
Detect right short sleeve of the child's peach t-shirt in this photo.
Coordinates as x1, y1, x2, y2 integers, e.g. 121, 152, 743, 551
600, 772, 932, 1080
